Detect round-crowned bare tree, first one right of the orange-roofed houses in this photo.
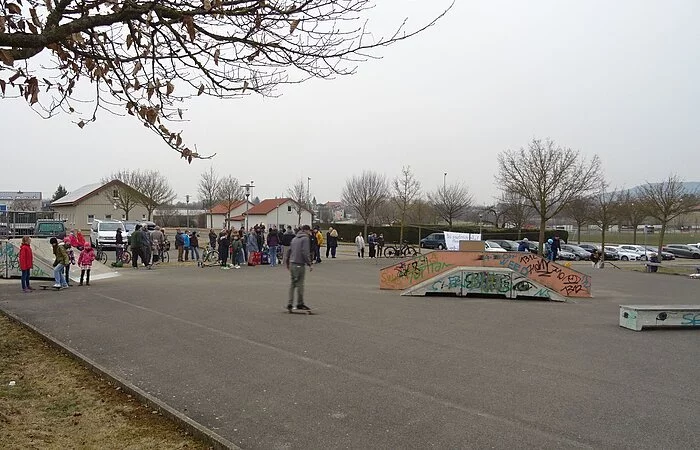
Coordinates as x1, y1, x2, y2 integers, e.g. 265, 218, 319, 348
342, 170, 389, 238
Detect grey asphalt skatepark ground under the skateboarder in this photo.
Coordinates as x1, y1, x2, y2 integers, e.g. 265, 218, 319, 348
0, 258, 700, 449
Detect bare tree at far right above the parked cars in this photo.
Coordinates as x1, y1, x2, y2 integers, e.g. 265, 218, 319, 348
639, 175, 699, 255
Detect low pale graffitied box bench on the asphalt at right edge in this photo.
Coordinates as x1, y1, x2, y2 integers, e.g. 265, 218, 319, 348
620, 305, 700, 331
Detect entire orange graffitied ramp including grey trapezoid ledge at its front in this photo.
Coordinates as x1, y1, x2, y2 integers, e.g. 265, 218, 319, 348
379, 250, 591, 300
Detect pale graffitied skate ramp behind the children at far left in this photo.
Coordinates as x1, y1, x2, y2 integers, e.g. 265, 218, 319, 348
0, 238, 119, 281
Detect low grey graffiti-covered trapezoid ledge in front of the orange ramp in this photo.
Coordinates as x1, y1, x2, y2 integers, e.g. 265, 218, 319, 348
401, 266, 566, 302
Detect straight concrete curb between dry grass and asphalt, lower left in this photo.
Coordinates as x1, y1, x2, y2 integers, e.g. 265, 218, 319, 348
0, 308, 241, 450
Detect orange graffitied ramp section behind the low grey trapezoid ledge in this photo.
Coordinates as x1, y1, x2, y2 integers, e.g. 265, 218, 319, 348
379, 251, 591, 298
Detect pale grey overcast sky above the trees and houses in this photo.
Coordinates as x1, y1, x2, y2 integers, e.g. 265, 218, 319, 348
0, 0, 700, 202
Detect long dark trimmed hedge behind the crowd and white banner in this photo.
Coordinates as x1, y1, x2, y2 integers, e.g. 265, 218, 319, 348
321, 223, 569, 245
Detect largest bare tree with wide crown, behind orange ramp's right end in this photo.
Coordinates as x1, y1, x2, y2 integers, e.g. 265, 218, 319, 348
496, 139, 600, 254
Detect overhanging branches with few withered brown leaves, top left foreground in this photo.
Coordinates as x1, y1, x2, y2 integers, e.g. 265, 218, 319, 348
0, 0, 447, 162
